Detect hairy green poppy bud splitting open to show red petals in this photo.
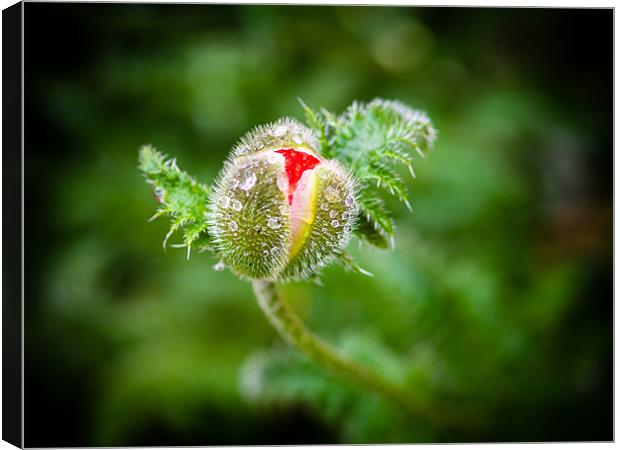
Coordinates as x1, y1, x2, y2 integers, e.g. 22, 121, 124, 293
208, 119, 357, 280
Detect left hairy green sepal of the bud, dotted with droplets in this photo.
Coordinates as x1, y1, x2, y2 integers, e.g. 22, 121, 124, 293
208, 151, 290, 279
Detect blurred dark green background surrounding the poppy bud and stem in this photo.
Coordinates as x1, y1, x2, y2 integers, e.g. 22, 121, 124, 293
25, 3, 613, 446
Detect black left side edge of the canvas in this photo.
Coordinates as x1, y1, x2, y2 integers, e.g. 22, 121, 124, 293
2, 2, 24, 447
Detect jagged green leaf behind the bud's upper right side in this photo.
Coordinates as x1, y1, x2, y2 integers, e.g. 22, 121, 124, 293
300, 99, 437, 248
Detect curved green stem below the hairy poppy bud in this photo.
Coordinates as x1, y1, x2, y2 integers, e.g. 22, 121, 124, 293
253, 280, 428, 414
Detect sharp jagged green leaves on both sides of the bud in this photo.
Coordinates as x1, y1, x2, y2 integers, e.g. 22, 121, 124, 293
140, 99, 437, 274
